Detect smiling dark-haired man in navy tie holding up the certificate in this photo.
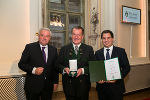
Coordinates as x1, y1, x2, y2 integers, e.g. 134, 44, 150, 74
95, 30, 130, 100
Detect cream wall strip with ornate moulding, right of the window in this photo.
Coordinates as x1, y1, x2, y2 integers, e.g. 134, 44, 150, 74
87, 0, 101, 50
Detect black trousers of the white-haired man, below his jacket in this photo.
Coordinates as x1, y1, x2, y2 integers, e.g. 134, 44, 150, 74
25, 91, 52, 100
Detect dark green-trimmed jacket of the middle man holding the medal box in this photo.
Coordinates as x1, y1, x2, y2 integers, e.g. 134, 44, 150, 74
58, 43, 94, 75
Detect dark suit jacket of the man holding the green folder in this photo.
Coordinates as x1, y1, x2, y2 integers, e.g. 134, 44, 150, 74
95, 46, 130, 92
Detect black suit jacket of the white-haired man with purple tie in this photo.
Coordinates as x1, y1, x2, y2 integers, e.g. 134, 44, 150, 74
18, 42, 58, 93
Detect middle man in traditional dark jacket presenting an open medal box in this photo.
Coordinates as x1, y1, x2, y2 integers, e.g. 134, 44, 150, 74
58, 26, 94, 100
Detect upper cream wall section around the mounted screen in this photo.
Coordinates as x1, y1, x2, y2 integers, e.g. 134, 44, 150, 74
116, 0, 150, 65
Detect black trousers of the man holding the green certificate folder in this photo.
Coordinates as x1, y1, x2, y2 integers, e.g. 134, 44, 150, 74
96, 84, 123, 100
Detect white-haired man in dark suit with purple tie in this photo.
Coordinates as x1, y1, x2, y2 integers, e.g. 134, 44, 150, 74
18, 28, 58, 100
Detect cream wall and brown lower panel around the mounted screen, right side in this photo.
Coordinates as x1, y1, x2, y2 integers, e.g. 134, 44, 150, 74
116, 0, 150, 92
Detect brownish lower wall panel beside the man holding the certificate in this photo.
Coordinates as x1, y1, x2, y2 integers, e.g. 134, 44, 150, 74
125, 64, 150, 92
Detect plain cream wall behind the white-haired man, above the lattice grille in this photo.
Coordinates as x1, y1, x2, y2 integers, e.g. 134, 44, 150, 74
0, 0, 41, 76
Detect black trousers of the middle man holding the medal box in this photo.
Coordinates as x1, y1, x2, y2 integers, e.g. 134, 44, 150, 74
63, 77, 90, 100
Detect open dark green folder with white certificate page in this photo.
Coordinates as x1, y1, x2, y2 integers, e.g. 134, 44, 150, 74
89, 58, 121, 82
